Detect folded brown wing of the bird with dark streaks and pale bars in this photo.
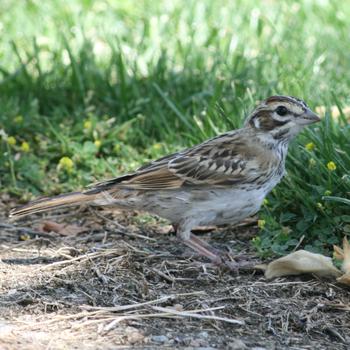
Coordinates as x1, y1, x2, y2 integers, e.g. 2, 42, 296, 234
87, 133, 252, 191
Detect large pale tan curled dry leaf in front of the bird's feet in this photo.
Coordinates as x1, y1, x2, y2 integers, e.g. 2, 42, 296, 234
265, 250, 341, 279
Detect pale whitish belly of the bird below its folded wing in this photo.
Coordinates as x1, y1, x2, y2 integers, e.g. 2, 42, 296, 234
144, 189, 266, 225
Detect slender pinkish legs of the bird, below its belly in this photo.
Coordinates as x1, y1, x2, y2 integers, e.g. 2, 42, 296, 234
174, 225, 222, 264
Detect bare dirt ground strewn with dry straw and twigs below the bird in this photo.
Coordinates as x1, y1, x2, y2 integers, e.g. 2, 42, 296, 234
0, 204, 350, 350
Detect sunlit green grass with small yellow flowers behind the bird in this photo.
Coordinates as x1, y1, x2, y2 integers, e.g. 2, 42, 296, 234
0, 0, 350, 254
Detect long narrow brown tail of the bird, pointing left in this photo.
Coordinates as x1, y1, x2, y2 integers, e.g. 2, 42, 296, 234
10, 191, 98, 218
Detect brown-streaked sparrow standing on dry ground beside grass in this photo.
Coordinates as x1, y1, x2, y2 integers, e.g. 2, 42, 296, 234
10, 95, 320, 264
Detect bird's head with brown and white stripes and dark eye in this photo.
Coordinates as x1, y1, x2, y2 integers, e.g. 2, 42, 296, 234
245, 96, 321, 141
